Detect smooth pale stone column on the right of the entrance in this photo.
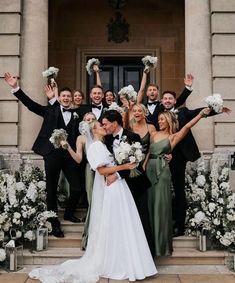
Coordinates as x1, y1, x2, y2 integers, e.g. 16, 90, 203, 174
185, 0, 214, 151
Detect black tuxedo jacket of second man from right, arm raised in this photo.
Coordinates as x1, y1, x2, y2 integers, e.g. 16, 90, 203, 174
145, 87, 192, 130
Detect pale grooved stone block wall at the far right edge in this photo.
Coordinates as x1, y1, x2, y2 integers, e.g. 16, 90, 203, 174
211, 0, 235, 150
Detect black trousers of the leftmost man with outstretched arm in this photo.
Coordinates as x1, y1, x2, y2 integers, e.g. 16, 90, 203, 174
44, 149, 81, 217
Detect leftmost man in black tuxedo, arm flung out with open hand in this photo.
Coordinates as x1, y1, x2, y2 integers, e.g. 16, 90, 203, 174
5, 73, 83, 237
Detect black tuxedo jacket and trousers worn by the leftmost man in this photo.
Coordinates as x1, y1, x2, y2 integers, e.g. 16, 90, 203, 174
14, 89, 80, 222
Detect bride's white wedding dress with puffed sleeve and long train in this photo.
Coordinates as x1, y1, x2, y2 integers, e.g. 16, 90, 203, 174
29, 141, 157, 283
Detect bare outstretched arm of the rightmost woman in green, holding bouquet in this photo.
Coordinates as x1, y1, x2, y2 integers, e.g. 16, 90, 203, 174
170, 107, 211, 149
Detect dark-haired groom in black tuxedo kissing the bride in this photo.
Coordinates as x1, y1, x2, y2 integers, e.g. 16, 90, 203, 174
102, 110, 153, 254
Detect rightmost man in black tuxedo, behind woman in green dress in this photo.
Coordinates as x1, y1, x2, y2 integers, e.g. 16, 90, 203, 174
162, 91, 230, 236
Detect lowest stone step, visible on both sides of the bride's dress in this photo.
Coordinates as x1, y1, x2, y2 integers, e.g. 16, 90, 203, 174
21, 247, 228, 266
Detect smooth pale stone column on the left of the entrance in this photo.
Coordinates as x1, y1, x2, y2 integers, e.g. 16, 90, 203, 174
19, 0, 48, 151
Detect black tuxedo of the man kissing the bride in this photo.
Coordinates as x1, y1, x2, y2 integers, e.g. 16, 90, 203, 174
105, 129, 154, 255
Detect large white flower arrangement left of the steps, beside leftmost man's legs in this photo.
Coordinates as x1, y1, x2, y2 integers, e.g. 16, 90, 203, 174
0, 163, 56, 248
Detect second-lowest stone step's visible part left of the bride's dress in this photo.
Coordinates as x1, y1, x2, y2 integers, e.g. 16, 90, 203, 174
48, 232, 82, 248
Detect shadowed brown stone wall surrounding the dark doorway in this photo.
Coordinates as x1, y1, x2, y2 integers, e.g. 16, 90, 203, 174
49, 0, 185, 96
